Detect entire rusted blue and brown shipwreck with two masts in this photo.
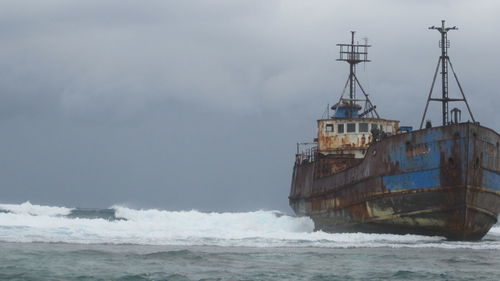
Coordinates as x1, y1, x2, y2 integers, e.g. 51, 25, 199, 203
289, 21, 500, 240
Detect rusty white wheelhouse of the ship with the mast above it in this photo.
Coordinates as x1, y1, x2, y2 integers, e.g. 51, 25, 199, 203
296, 31, 400, 175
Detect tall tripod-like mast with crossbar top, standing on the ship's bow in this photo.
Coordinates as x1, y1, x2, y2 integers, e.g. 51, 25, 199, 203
420, 20, 475, 129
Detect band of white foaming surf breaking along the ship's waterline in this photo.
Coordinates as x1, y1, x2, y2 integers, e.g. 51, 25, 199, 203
0, 202, 500, 249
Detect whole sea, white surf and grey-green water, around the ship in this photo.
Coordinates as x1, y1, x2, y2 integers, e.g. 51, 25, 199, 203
0, 202, 500, 281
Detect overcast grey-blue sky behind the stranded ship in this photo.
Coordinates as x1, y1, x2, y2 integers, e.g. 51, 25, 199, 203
0, 0, 500, 212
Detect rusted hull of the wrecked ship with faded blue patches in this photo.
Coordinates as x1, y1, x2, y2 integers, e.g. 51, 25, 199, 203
289, 123, 500, 240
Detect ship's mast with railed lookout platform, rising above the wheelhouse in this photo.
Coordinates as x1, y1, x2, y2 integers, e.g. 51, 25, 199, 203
332, 31, 380, 118
